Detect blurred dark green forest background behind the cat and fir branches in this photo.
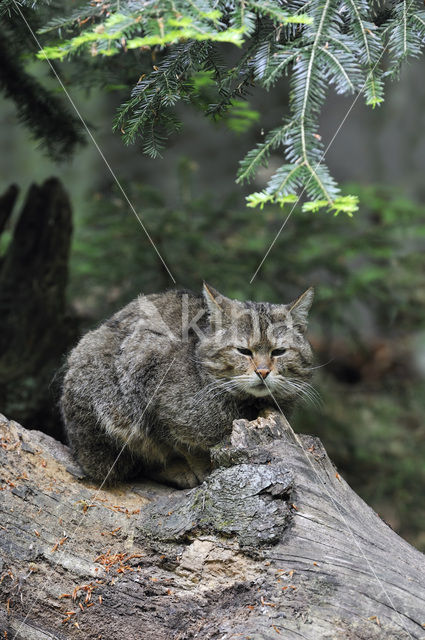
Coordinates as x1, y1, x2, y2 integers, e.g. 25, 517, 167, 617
0, 10, 425, 551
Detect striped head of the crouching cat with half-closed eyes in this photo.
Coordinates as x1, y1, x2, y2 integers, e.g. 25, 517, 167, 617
198, 284, 314, 400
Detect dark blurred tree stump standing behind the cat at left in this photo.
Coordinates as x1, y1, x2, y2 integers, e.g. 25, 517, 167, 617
0, 178, 77, 435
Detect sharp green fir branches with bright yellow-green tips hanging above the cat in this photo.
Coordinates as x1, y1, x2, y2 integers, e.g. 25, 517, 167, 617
5, 0, 425, 215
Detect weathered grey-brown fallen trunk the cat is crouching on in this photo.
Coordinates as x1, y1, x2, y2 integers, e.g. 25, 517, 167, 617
0, 413, 425, 640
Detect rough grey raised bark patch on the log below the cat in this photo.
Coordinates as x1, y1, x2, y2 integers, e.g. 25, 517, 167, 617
138, 463, 293, 547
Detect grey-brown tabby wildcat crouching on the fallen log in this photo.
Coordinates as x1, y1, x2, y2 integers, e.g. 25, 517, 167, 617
61, 284, 313, 488
